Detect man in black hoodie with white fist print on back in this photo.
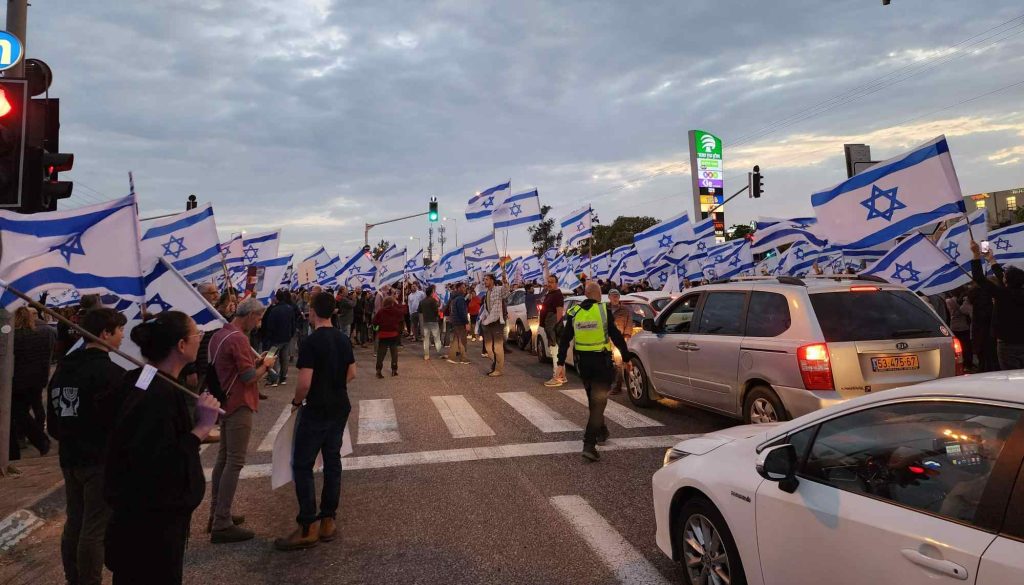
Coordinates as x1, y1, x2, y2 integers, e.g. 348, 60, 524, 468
46, 308, 125, 585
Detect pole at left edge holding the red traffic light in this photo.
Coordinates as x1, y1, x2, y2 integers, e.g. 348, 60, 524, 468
0, 0, 29, 476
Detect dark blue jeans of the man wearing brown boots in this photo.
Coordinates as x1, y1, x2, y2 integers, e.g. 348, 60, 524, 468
292, 407, 348, 527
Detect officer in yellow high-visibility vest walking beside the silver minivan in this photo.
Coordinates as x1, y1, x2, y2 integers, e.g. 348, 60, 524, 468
558, 281, 632, 461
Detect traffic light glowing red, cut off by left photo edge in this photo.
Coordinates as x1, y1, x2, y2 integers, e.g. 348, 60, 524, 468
0, 79, 29, 208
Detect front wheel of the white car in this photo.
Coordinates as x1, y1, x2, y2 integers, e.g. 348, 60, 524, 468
676, 497, 746, 585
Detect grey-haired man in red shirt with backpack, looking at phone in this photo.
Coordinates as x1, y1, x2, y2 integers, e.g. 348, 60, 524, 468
207, 298, 276, 544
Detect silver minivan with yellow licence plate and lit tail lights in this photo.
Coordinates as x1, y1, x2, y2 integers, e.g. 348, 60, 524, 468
628, 277, 963, 423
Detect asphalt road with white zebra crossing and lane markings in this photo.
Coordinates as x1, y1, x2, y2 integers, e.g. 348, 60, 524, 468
0, 341, 735, 585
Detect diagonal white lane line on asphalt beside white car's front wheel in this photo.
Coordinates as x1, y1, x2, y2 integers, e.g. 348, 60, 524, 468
551, 496, 669, 585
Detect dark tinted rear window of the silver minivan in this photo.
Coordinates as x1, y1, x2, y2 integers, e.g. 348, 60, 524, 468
810, 290, 947, 341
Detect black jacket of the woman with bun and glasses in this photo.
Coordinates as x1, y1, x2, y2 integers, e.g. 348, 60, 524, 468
103, 369, 206, 514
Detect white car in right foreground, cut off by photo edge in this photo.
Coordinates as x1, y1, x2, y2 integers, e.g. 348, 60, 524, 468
653, 370, 1024, 585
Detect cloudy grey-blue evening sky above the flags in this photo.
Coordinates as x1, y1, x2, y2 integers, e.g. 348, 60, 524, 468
28, 0, 1024, 258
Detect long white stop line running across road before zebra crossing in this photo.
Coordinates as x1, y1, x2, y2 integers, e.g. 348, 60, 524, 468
203, 434, 699, 482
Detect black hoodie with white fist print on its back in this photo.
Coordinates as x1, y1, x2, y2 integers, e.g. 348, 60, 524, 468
46, 347, 125, 467
